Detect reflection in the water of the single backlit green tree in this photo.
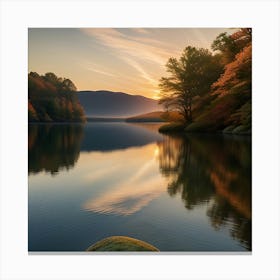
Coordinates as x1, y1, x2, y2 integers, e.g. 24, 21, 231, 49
159, 136, 214, 209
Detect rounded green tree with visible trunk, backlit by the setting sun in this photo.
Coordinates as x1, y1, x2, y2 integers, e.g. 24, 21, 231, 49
159, 46, 222, 124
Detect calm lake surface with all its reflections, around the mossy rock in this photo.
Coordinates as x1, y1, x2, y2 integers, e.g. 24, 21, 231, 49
28, 123, 252, 251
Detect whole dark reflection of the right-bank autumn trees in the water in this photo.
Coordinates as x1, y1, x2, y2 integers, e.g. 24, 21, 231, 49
159, 135, 251, 250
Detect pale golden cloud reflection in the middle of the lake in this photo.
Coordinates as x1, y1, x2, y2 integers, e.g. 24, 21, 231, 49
83, 144, 166, 216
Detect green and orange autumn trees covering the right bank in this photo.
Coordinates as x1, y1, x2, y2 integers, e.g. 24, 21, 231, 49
159, 28, 252, 134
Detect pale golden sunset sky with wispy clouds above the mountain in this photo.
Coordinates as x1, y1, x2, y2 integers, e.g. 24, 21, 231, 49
28, 28, 233, 99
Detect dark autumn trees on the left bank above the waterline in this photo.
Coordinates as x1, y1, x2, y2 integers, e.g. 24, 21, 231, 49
28, 72, 85, 122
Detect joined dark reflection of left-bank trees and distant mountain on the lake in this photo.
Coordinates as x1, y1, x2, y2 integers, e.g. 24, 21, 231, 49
28, 123, 162, 175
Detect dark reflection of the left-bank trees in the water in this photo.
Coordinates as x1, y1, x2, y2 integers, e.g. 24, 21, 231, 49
28, 124, 83, 175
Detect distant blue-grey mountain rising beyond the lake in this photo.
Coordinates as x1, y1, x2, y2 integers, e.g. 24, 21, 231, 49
77, 90, 162, 117
